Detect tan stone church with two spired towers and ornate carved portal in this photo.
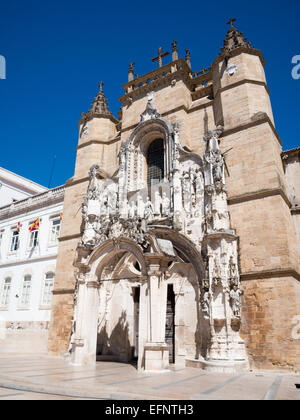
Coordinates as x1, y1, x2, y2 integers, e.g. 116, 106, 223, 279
49, 19, 300, 371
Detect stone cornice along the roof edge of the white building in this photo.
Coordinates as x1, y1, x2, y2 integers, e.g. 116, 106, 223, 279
0, 186, 65, 220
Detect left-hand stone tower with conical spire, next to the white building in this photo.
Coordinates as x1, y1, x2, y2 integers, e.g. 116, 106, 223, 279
49, 82, 120, 355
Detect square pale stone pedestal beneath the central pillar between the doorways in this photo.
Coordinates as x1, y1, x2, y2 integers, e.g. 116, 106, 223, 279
145, 343, 169, 371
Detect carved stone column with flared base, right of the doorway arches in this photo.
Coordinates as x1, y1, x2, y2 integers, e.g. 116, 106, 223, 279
204, 235, 248, 372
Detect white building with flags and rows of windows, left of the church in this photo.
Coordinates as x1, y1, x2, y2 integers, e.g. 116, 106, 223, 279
0, 169, 64, 352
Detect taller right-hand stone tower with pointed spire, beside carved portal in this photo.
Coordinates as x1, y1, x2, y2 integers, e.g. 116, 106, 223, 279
212, 19, 300, 367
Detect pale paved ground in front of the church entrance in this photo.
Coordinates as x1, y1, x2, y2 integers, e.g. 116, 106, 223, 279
0, 354, 300, 400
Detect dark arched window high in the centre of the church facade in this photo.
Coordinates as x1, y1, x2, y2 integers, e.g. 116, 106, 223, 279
147, 139, 165, 187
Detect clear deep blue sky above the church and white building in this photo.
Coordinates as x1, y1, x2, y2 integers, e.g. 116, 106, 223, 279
0, 0, 300, 187
